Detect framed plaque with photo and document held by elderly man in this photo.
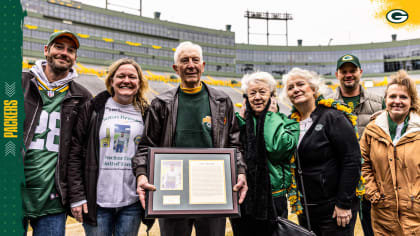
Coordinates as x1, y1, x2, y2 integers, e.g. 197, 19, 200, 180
146, 148, 240, 218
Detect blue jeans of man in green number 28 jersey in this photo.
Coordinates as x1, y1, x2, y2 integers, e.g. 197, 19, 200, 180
23, 212, 67, 236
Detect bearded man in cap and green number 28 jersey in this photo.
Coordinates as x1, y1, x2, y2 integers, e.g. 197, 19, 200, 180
22, 30, 92, 236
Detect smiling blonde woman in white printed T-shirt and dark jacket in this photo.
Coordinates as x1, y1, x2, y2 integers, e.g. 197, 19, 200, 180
68, 59, 153, 236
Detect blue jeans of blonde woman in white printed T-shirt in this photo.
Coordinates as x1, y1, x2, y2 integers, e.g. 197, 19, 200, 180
83, 201, 141, 236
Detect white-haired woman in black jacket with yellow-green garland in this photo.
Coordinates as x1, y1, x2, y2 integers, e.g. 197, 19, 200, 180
283, 68, 361, 236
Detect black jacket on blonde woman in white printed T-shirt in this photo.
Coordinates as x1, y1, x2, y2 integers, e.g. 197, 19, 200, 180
68, 91, 154, 228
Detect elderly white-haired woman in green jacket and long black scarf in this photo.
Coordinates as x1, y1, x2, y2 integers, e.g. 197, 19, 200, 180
231, 72, 301, 236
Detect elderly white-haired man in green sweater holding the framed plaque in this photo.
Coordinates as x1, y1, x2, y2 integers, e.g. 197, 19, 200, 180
132, 42, 248, 236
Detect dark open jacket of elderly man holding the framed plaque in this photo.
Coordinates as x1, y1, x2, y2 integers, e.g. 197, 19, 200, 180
132, 83, 246, 176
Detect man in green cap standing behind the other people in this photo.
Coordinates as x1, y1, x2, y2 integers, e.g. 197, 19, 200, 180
331, 54, 383, 236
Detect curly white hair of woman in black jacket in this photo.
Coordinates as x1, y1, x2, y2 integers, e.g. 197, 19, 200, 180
281, 67, 328, 104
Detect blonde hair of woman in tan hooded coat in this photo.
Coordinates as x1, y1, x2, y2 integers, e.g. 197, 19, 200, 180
385, 70, 420, 115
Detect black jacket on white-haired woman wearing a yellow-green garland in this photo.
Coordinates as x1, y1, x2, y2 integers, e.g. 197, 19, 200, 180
298, 105, 361, 209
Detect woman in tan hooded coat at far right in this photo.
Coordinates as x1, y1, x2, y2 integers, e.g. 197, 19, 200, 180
360, 70, 420, 235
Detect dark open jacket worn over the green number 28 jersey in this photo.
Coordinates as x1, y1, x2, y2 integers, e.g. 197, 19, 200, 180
22, 72, 92, 206
